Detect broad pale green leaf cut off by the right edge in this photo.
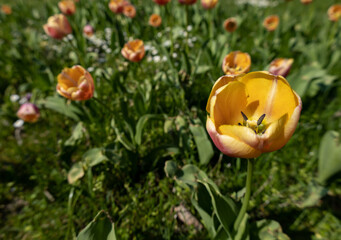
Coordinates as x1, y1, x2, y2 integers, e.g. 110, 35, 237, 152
318, 131, 341, 183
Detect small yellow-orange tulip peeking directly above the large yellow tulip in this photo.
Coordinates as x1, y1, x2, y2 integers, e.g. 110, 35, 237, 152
222, 51, 251, 75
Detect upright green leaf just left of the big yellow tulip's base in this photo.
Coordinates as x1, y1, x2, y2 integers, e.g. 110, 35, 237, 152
189, 125, 214, 164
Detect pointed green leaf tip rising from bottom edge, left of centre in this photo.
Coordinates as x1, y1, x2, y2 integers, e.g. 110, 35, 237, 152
77, 211, 117, 240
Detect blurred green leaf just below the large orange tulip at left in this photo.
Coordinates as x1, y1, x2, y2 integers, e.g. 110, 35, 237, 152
42, 96, 82, 121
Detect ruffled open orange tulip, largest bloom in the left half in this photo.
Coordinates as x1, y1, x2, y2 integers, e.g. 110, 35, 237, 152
57, 65, 95, 101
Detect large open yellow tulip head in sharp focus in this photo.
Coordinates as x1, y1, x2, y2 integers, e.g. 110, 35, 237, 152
206, 72, 302, 158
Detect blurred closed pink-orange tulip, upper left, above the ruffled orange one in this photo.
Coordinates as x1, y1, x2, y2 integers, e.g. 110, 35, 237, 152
43, 14, 72, 39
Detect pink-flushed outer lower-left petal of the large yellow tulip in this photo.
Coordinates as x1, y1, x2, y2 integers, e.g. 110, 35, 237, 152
206, 117, 261, 158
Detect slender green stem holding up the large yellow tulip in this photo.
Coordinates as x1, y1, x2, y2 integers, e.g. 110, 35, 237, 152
234, 159, 254, 231
